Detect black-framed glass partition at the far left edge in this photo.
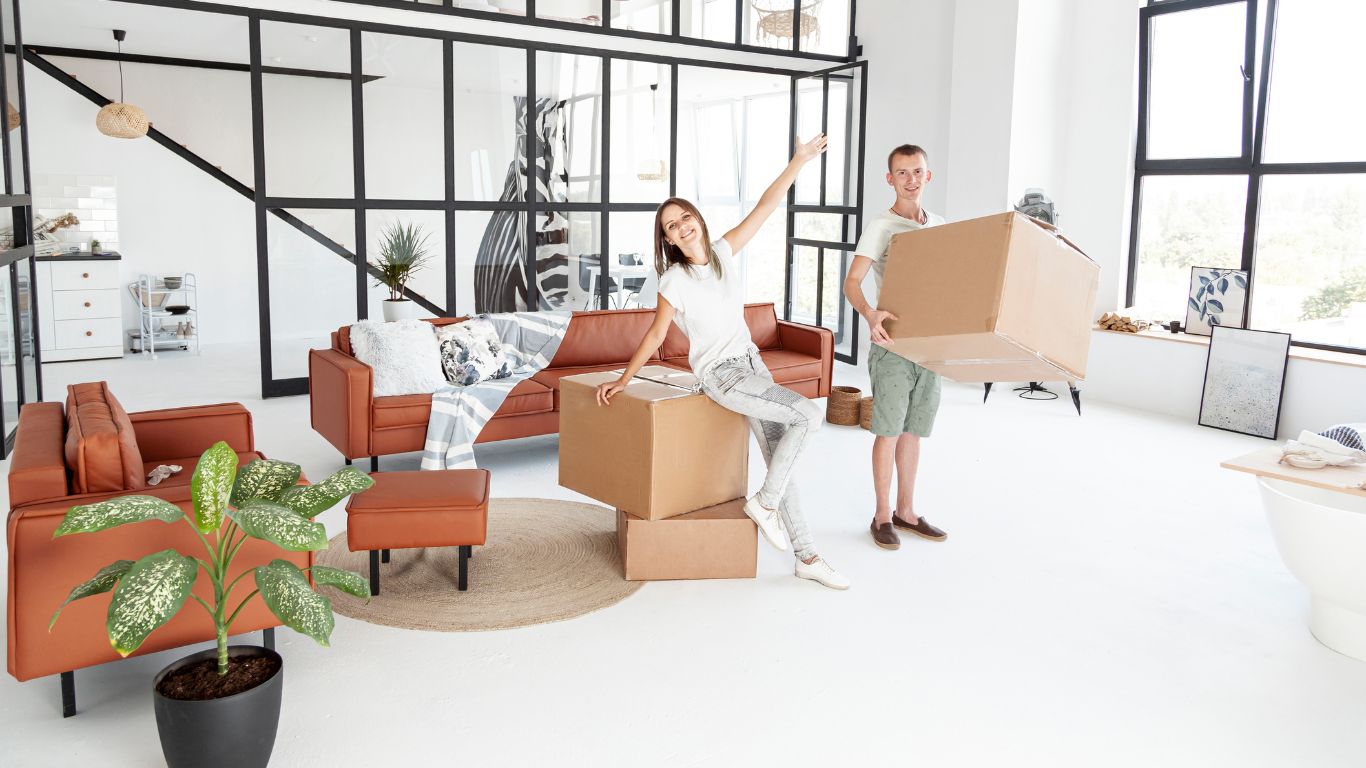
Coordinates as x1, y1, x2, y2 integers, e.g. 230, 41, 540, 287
0, 0, 42, 458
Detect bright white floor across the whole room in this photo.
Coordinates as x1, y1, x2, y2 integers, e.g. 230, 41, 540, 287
8, 347, 1366, 768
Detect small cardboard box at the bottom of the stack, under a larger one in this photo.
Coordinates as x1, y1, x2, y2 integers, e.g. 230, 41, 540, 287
616, 499, 759, 581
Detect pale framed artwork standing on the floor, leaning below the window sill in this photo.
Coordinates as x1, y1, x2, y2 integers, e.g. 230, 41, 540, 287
1199, 325, 1290, 440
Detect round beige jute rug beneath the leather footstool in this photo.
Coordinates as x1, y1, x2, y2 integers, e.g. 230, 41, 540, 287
317, 499, 642, 631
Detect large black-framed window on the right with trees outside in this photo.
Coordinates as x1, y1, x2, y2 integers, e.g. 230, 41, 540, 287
1127, 0, 1366, 354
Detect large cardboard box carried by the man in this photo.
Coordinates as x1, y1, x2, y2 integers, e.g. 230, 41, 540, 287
878, 212, 1100, 381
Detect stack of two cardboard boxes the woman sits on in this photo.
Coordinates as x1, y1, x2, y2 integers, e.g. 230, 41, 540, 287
560, 365, 758, 581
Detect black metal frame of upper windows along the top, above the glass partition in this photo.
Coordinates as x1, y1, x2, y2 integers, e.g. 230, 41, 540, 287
312, 0, 858, 61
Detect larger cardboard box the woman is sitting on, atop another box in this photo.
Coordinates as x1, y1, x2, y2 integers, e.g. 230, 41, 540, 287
560, 365, 750, 521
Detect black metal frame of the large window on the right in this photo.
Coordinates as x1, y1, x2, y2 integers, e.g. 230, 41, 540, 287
1124, 0, 1366, 354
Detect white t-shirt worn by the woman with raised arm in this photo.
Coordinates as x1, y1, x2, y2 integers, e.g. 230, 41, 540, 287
660, 238, 755, 377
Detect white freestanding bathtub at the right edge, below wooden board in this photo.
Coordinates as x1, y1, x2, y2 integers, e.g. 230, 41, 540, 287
1257, 477, 1366, 661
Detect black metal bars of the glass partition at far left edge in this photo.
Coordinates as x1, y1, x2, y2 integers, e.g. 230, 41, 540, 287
0, 0, 42, 458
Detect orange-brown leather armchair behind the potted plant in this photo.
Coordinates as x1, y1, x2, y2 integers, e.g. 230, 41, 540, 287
5, 381, 313, 716
